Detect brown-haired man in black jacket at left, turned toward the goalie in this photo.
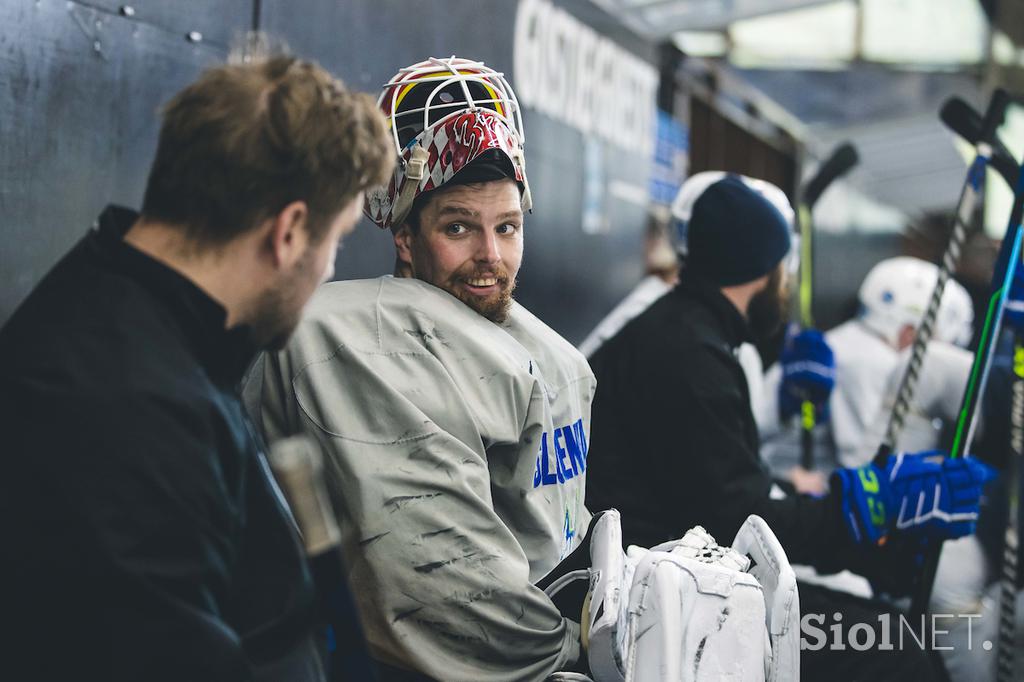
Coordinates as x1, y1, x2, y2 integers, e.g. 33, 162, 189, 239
0, 47, 393, 682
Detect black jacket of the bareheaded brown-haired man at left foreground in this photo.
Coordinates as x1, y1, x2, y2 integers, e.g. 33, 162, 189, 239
0, 208, 319, 681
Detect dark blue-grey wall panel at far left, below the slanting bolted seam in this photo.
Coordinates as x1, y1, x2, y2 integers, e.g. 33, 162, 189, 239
0, 0, 232, 324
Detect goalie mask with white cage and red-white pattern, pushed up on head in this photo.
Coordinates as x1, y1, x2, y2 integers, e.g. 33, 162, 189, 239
365, 56, 532, 228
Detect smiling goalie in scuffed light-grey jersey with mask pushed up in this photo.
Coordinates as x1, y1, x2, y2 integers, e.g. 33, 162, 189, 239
249, 57, 595, 681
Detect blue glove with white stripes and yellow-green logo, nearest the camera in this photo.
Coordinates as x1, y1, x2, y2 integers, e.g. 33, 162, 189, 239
831, 450, 995, 546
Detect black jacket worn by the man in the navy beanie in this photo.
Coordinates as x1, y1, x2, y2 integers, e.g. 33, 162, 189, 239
587, 276, 859, 570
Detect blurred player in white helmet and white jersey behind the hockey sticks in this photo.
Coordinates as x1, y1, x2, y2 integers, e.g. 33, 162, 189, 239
759, 256, 986, 627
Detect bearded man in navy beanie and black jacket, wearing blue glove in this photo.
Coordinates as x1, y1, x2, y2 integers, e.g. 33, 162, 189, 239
587, 174, 989, 680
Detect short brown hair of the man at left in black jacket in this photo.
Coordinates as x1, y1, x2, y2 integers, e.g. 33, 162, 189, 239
142, 55, 395, 245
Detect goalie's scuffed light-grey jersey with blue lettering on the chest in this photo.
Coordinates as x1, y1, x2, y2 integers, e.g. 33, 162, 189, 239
254, 276, 595, 681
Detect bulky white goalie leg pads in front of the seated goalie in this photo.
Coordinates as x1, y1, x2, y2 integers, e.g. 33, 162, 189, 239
587, 510, 800, 682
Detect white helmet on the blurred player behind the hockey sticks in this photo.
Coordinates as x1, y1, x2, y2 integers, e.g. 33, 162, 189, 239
857, 256, 974, 347
